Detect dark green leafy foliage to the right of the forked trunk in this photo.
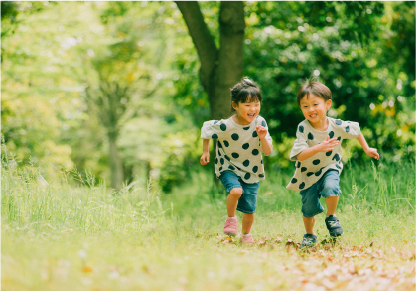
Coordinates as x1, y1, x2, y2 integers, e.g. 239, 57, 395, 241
245, 2, 415, 161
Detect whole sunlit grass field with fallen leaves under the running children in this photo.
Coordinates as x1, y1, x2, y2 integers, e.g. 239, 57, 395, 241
1, 157, 416, 291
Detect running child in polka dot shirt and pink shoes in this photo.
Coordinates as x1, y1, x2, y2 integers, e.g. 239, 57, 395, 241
201, 78, 273, 244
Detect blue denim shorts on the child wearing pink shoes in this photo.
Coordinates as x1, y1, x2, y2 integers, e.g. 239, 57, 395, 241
218, 171, 259, 214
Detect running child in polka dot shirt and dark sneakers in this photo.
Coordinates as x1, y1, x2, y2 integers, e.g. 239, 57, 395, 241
287, 80, 379, 247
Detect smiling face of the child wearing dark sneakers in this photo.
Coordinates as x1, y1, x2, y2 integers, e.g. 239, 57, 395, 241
300, 94, 332, 126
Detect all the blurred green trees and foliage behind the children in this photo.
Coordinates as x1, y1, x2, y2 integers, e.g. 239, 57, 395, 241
1, 1, 415, 193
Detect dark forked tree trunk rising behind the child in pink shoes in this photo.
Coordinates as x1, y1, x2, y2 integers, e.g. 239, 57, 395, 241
176, 1, 245, 119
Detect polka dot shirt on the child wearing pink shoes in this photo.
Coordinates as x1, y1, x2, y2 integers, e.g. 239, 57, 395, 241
201, 115, 272, 184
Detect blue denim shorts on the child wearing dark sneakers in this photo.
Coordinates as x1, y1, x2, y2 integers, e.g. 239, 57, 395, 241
300, 169, 342, 217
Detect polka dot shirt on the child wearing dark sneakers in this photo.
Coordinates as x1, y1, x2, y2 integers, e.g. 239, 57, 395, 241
286, 117, 360, 191
